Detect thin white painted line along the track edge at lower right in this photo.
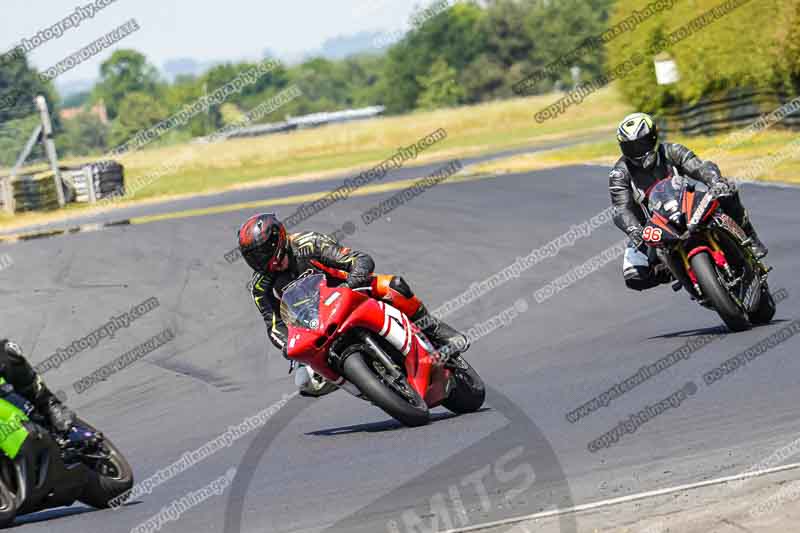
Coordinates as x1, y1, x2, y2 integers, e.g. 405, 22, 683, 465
442, 463, 800, 533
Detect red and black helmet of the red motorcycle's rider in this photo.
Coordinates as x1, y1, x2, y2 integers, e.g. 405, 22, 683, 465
239, 213, 287, 274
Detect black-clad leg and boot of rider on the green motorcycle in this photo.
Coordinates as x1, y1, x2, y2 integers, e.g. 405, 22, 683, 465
0, 339, 75, 433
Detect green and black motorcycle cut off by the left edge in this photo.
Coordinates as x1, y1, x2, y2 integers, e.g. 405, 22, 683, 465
0, 378, 133, 528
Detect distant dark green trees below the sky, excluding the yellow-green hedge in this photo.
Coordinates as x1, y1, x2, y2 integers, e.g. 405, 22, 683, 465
0, 0, 636, 160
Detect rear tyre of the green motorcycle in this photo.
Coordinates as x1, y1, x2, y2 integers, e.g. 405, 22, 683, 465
78, 420, 133, 509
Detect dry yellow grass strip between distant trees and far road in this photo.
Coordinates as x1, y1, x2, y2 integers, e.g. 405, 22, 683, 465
0, 88, 629, 229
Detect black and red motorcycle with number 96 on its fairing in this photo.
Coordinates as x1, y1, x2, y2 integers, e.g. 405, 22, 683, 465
644, 176, 776, 331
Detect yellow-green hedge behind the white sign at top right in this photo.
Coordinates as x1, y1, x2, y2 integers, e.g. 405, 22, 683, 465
607, 0, 800, 113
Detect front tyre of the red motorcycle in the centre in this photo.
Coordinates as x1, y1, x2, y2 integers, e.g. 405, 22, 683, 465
342, 352, 430, 427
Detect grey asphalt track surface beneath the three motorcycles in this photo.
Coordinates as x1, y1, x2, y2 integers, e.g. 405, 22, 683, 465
0, 166, 800, 533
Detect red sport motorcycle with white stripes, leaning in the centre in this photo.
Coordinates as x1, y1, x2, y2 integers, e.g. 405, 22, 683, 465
281, 274, 486, 426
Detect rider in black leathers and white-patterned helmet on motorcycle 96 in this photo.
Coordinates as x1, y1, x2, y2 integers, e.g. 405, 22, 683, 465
608, 113, 767, 291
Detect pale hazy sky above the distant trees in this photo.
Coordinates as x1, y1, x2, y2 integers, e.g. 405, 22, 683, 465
0, 0, 424, 84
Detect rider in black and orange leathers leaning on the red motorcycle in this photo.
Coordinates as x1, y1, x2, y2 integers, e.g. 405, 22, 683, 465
238, 213, 469, 396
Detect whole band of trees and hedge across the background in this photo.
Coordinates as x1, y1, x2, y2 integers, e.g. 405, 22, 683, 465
0, 0, 800, 164
